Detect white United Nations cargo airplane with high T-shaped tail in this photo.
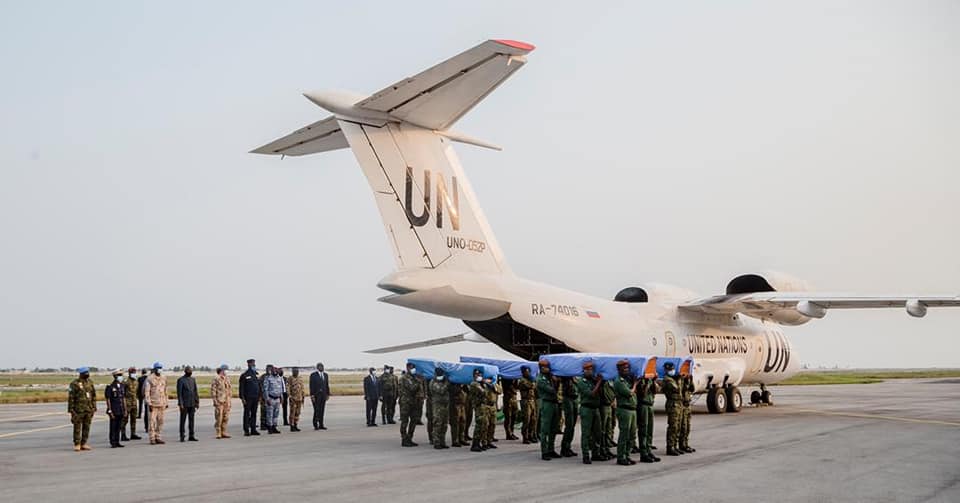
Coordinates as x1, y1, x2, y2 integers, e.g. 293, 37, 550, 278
253, 40, 960, 412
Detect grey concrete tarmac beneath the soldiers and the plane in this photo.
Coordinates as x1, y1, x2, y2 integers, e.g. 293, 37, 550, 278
0, 376, 960, 503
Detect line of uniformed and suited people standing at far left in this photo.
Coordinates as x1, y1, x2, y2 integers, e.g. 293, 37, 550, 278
67, 359, 330, 451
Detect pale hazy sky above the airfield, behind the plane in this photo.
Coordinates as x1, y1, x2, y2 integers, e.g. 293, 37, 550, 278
0, 1, 960, 367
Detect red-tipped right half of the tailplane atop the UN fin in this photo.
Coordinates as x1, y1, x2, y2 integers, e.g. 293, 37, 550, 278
355, 40, 534, 131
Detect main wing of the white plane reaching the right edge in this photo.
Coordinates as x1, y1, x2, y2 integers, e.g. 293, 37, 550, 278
679, 292, 960, 319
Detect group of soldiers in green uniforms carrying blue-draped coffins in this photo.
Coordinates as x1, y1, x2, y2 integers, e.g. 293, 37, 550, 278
392, 360, 695, 465
